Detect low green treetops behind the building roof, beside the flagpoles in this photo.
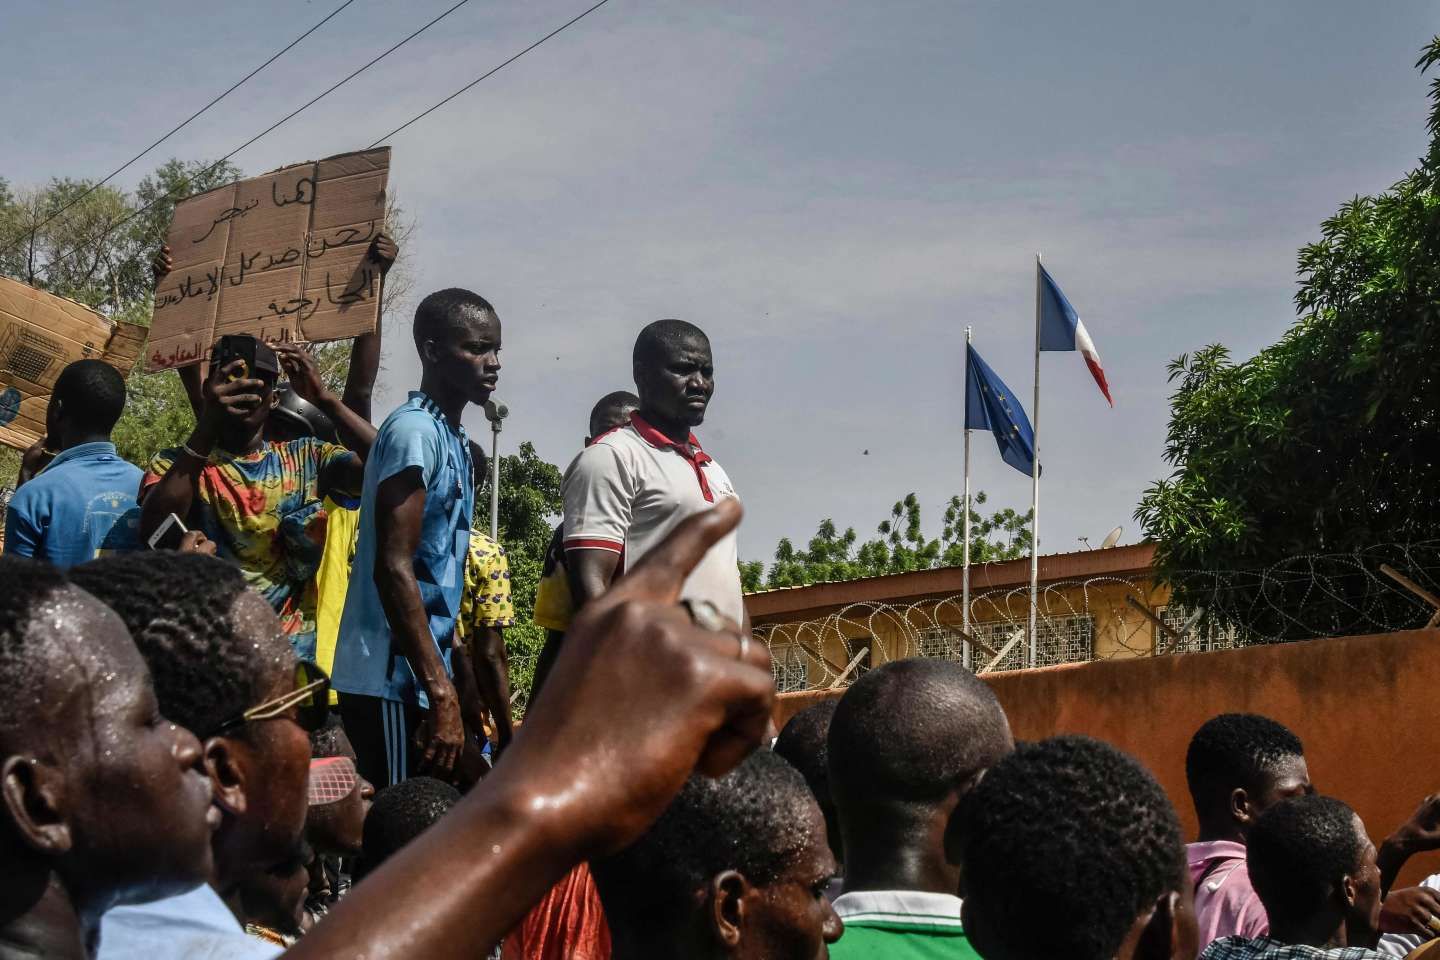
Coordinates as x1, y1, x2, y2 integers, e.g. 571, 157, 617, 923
740, 491, 1030, 592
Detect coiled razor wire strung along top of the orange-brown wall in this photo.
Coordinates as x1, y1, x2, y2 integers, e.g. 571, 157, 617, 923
755, 540, 1440, 692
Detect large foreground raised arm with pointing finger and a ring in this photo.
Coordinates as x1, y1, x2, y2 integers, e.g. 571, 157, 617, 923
284, 501, 775, 960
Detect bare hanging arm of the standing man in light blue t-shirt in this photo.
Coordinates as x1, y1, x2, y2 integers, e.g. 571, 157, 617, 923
373, 466, 465, 779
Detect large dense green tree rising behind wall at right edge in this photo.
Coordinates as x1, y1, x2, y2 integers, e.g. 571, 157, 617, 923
1136, 37, 1440, 638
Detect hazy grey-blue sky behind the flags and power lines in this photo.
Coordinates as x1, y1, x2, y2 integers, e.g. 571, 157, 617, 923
0, 0, 1440, 569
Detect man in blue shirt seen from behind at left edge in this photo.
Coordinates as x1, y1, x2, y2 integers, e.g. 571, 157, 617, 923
4, 360, 144, 567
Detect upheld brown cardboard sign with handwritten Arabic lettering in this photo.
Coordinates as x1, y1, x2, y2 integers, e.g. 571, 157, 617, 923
145, 147, 390, 371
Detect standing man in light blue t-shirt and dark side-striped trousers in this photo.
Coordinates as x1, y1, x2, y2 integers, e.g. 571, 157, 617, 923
334, 289, 500, 786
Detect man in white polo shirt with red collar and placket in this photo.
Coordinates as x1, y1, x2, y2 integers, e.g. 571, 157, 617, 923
562, 320, 746, 623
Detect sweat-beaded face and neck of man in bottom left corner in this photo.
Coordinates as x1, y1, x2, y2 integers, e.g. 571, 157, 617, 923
0, 587, 217, 957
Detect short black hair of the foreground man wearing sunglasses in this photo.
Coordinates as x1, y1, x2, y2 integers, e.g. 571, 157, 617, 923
71, 550, 289, 737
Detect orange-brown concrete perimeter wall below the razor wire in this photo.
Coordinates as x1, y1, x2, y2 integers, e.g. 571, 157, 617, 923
776, 630, 1440, 884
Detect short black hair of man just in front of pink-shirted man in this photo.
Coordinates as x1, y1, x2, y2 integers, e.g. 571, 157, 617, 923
1246, 796, 1365, 925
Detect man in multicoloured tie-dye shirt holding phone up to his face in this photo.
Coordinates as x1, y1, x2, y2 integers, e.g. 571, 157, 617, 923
140, 341, 374, 661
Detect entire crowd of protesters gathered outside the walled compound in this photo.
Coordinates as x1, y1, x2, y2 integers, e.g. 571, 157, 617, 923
0, 237, 1440, 960
